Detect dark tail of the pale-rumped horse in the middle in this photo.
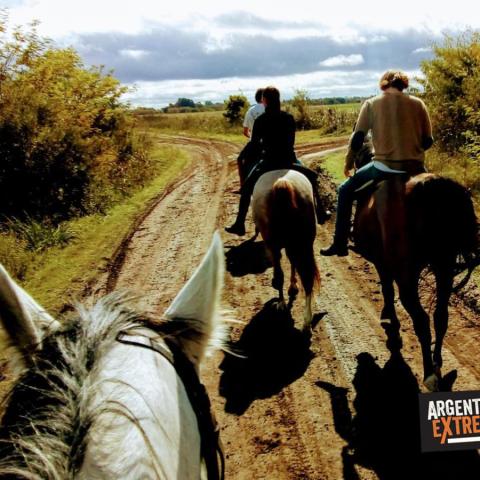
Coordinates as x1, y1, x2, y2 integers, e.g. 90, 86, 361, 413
271, 178, 320, 294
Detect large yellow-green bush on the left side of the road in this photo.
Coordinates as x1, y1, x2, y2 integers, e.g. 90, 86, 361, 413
0, 17, 151, 222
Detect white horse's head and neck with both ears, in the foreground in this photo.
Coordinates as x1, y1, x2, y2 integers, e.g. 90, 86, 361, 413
0, 234, 225, 480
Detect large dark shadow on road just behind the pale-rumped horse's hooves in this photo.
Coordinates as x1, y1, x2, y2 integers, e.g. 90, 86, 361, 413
219, 299, 313, 415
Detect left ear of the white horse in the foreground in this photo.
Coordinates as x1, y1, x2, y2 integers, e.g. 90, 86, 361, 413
0, 264, 59, 355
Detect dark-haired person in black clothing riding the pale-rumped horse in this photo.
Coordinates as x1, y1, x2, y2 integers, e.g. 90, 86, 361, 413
225, 87, 326, 236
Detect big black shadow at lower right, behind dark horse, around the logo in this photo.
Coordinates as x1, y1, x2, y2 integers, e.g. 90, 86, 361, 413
317, 322, 480, 480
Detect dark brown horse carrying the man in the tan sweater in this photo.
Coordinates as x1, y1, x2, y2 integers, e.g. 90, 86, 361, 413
353, 149, 480, 390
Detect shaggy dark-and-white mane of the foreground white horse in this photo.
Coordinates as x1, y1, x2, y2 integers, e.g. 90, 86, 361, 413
0, 292, 186, 480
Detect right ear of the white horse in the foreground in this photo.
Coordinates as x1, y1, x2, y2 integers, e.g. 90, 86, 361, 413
165, 232, 225, 363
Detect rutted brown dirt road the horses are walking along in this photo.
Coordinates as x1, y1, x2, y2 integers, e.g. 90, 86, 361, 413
106, 137, 480, 480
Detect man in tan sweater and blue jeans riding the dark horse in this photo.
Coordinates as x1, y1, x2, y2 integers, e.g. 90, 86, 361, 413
320, 70, 433, 256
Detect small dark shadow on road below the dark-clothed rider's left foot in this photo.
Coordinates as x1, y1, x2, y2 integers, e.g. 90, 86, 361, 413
225, 239, 272, 277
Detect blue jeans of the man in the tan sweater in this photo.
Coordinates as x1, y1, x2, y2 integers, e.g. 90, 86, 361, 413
333, 162, 392, 247
